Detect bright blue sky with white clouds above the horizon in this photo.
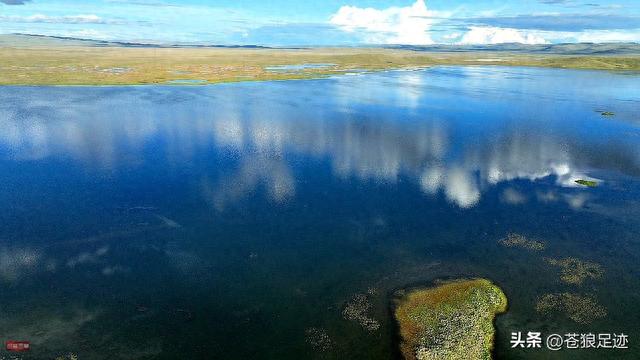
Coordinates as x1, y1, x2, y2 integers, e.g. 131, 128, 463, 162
0, 0, 640, 46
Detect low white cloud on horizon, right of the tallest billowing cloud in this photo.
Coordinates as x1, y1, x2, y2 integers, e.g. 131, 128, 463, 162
459, 26, 549, 45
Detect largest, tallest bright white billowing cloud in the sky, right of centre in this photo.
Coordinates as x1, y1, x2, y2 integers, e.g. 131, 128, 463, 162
330, 0, 435, 45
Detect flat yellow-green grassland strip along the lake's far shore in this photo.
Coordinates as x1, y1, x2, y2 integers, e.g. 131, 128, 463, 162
0, 38, 640, 85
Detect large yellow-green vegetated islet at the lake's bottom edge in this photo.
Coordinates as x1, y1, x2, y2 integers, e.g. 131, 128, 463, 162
394, 279, 507, 360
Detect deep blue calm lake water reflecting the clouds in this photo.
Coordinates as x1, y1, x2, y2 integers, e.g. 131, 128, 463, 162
0, 67, 640, 359
